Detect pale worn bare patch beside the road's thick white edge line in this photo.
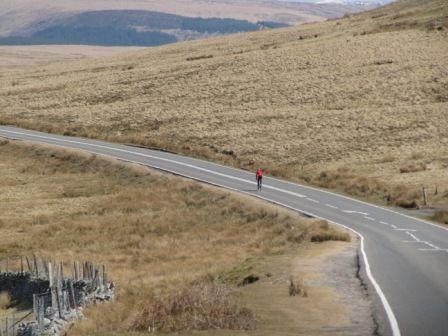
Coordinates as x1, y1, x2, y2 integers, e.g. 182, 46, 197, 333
200, 237, 375, 336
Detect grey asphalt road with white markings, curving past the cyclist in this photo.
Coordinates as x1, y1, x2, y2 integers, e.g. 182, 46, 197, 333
0, 126, 448, 336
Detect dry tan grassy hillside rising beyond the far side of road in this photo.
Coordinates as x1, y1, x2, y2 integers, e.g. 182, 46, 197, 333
0, 0, 448, 214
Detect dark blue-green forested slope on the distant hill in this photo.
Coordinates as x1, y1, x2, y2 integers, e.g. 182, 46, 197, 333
0, 10, 287, 46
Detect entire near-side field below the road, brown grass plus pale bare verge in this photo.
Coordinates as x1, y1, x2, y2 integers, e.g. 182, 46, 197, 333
0, 141, 364, 335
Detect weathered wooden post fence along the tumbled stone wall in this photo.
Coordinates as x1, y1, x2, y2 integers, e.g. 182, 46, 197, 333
0, 256, 114, 336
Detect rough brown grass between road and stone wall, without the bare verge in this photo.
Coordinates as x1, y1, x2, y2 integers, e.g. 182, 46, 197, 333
0, 141, 349, 335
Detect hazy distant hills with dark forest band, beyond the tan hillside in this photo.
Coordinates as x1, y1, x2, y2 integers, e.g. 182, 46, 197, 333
0, 0, 377, 46
